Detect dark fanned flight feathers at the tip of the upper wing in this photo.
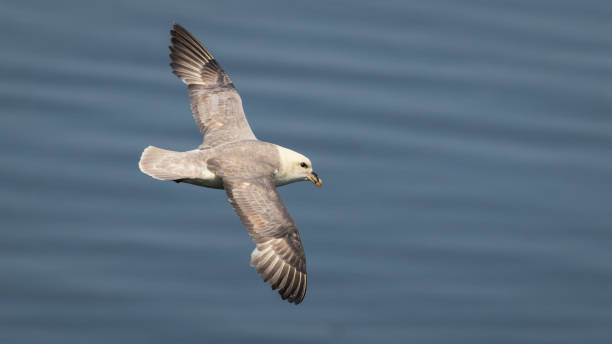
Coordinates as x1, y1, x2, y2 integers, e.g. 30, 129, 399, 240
169, 23, 232, 86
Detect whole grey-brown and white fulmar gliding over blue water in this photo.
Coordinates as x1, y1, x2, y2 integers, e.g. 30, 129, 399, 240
138, 24, 322, 304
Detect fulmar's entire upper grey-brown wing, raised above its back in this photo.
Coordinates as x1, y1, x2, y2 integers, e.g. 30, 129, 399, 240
170, 24, 255, 147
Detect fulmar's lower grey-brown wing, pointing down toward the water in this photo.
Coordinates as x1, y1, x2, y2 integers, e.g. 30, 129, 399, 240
223, 175, 307, 304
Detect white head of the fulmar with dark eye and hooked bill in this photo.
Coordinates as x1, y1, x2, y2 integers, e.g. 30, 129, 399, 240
274, 146, 323, 186
